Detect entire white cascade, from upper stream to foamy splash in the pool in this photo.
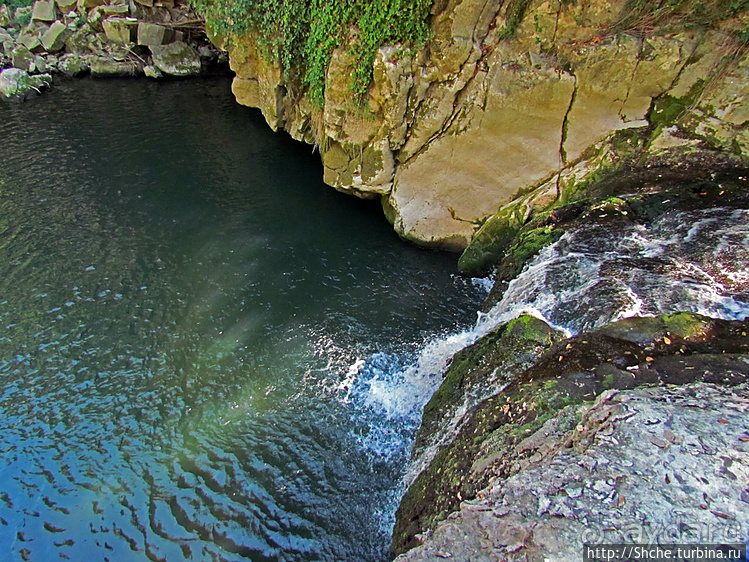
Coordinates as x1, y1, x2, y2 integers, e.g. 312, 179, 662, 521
345, 208, 749, 508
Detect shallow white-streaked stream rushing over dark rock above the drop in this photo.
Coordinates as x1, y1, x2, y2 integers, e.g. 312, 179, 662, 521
478, 207, 749, 335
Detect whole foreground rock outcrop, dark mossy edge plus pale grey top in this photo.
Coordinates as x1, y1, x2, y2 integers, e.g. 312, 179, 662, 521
393, 313, 749, 562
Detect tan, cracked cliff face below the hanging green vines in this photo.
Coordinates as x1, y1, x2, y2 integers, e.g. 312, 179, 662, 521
212, 0, 749, 250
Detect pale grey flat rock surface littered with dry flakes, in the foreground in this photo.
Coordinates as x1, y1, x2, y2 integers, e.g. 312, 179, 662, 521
396, 378, 749, 562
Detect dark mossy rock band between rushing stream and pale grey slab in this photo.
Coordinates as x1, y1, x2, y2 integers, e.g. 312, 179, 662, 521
392, 313, 749, 554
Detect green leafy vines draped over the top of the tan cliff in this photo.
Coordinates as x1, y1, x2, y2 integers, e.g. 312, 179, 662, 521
192, 0, 431, 105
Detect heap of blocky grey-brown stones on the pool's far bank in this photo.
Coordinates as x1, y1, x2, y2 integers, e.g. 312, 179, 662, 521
0, 0, 228, 101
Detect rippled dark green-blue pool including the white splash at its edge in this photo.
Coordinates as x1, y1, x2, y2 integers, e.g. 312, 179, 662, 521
0, 79, 485, 562
